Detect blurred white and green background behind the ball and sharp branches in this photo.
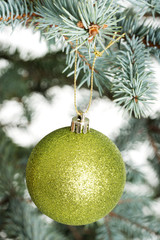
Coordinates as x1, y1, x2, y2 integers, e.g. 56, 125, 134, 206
0, 27, 160, 240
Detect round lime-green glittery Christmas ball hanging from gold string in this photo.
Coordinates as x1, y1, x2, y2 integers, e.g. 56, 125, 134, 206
26, 127, 126, 225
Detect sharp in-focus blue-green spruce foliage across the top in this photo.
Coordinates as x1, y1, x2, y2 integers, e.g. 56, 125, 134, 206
0, 0, 160, 117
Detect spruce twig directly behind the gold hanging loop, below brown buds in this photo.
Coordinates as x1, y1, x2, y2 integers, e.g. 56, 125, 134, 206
63, 43, 111, 95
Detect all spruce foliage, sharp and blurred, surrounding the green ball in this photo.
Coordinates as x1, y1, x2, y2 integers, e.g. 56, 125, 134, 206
0, 0, 160, 240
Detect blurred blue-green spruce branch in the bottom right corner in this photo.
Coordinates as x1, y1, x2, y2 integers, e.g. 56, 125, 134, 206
96, 192, 160, 240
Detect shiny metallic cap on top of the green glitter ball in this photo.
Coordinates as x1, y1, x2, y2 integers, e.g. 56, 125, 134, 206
71, 113, 89, 134
